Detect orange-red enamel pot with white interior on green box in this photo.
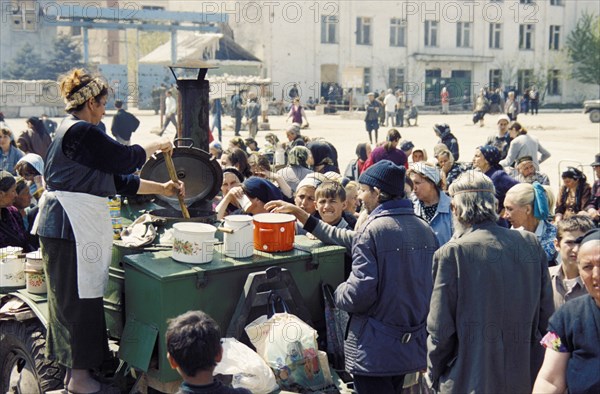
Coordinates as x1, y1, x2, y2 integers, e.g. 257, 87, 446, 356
252, 213, 296, 252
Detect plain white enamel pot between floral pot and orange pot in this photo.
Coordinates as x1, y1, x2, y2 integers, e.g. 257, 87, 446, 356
223, 215, 254, 259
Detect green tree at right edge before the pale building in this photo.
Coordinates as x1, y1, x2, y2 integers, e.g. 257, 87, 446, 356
566, 13, 600, 85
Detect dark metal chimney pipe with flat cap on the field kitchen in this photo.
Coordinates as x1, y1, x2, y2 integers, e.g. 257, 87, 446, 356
169, 60, 216, 152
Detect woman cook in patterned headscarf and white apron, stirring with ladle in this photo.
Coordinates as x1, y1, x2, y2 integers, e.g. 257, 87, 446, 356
33, 69, 184, 393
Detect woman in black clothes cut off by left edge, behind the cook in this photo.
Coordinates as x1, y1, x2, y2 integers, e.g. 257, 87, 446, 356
0, 170, 36, 252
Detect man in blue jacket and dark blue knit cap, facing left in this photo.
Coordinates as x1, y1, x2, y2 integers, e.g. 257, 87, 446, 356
335, 160, 438, 394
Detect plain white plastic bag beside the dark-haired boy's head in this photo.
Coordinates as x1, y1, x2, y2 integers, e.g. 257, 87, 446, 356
214, 338, 279, 394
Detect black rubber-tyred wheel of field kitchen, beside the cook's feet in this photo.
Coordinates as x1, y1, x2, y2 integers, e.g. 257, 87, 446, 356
0, 321, 65, 394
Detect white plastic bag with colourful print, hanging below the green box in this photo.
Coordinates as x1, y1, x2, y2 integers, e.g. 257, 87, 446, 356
246, 313, 332, 392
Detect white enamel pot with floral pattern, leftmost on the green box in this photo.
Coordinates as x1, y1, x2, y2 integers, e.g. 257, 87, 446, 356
172, 222, 219, 264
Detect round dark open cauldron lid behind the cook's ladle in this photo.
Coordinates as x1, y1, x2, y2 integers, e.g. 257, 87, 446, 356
140, 142, 223, 210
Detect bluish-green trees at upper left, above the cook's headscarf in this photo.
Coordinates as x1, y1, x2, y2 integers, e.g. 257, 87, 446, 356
0, 35, 84, 80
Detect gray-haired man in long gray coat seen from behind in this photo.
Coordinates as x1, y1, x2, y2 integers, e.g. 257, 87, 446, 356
427, 171, 554, 394
